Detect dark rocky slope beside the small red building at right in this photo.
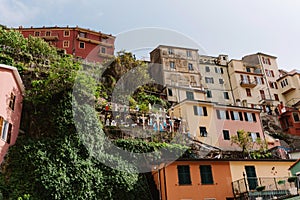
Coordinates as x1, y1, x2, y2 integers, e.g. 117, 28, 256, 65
261, 114, 300, 150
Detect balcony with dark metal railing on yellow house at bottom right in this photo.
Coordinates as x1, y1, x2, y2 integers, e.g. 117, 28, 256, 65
232, 177, 299, 200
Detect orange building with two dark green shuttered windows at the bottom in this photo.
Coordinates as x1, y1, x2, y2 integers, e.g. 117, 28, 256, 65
153, 160, 233, 200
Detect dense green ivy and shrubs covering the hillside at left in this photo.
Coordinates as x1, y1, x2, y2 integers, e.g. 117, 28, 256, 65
0, 28, 185, 200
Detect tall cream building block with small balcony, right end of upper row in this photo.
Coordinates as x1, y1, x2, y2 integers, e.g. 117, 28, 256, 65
228, 53, 284, 112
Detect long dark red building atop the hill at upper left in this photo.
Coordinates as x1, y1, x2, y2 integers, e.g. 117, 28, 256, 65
16, 26, 115, 62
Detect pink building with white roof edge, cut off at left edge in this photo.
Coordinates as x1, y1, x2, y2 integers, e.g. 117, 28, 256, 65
0, 64, 25, 163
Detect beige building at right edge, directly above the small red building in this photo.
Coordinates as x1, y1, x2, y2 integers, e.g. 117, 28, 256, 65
277, 70, 300, 108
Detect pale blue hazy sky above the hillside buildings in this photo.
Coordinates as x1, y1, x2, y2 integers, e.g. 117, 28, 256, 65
0, 0, 300, 71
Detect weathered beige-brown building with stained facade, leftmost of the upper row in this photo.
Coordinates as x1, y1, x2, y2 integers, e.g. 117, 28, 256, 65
150, 45, 205, 102
